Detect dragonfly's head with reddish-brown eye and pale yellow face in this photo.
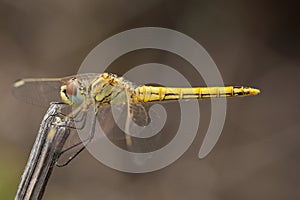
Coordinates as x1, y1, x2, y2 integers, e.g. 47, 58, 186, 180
60, 78, 84, 106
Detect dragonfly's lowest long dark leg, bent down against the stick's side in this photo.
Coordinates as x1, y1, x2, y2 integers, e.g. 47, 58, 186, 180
56, 112, 97, 167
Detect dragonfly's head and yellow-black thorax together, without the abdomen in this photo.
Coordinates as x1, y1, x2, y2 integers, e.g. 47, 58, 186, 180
60, 73, 134, 106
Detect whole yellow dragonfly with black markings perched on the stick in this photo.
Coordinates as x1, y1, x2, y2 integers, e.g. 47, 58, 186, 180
13, 73, 260, 166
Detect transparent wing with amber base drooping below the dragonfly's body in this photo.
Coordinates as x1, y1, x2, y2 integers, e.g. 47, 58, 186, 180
97, 103, 163, 153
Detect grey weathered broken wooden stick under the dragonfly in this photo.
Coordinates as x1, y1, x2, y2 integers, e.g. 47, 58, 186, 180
15, 103, 70, 200
